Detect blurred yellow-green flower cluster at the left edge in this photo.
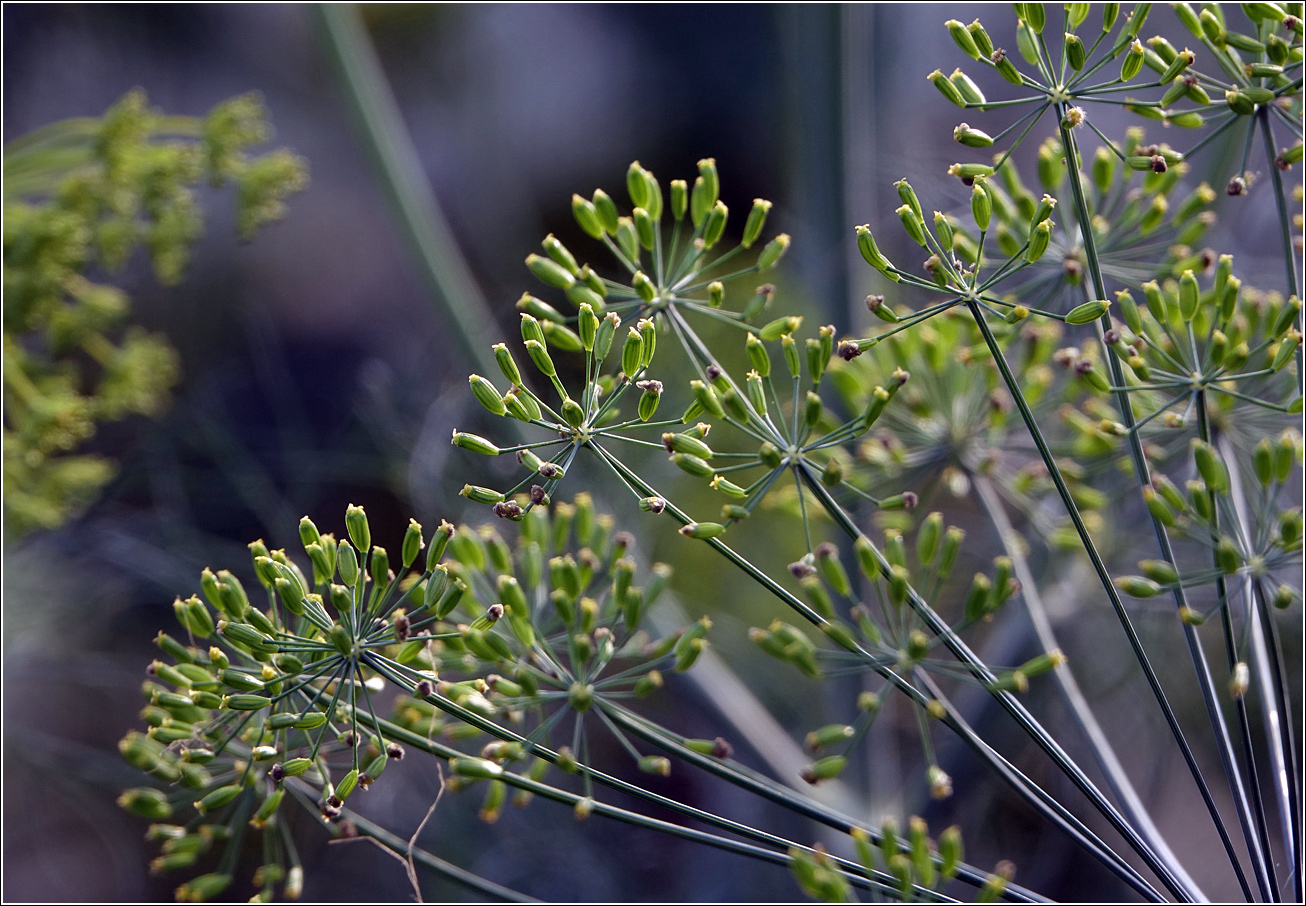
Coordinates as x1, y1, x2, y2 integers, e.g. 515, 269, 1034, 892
4, 90, 307, 537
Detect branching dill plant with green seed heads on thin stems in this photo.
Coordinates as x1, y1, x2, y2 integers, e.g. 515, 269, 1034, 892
124, 3, 1303, 902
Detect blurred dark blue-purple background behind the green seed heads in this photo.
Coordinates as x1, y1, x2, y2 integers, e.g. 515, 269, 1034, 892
3, 4, 1301, 901
